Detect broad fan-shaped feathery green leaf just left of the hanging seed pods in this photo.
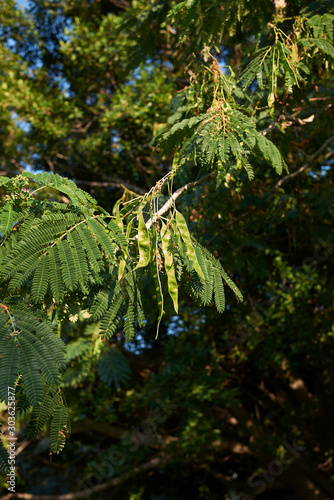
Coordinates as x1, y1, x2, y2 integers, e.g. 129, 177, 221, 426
0, 197, 127, 303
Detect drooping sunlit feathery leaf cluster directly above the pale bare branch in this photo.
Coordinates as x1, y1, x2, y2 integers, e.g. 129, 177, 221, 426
157, 100, 285, 186
